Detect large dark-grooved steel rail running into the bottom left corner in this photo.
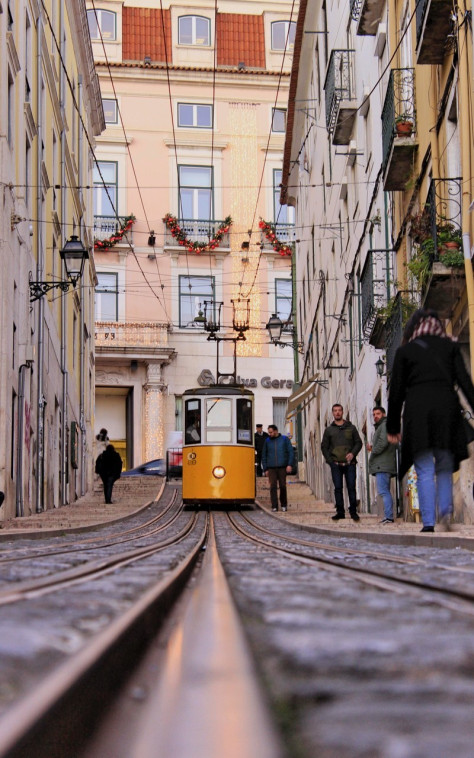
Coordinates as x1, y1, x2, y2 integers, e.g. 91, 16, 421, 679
0, 516, 208, 758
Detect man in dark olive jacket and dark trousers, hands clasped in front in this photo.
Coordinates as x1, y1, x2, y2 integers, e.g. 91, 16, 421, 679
321, 403, 362, 521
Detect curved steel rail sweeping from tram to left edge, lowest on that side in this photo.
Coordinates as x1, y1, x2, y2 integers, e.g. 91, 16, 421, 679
0, 513, 198, 607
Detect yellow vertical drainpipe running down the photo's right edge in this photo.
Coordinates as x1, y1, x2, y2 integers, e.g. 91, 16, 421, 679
458, 14, 474, 377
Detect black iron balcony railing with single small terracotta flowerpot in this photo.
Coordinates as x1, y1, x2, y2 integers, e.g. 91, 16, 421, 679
382, 68, 416, 167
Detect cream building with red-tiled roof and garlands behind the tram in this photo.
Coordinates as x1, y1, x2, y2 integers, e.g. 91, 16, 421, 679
89, 0, 296, 467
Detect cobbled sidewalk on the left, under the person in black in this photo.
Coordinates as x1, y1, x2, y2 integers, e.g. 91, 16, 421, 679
0, 476, 164, 541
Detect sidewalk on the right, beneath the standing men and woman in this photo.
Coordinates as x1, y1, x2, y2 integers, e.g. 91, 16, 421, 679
257, 476, 474, 550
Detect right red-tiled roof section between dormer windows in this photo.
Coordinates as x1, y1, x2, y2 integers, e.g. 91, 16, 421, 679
217, 13, 265, 68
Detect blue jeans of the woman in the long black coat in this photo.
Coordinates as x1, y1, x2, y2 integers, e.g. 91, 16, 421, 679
414, 448, 454, 526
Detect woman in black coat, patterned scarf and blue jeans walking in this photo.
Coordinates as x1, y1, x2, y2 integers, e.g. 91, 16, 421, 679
387, 309, 474, 532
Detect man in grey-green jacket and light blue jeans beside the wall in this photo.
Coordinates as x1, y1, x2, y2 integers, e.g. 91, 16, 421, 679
367, 405, 397, 524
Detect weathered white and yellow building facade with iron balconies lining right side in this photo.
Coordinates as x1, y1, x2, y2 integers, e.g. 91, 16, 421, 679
282, 0, 474, 521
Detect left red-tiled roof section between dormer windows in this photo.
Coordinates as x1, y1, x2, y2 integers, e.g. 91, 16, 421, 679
122, 6, 172, 63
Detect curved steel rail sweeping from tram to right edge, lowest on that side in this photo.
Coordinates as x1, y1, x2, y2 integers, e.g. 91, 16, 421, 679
227, 513, 474, 616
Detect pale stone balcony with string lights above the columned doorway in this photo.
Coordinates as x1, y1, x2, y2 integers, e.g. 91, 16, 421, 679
95, 321, 173, 359
